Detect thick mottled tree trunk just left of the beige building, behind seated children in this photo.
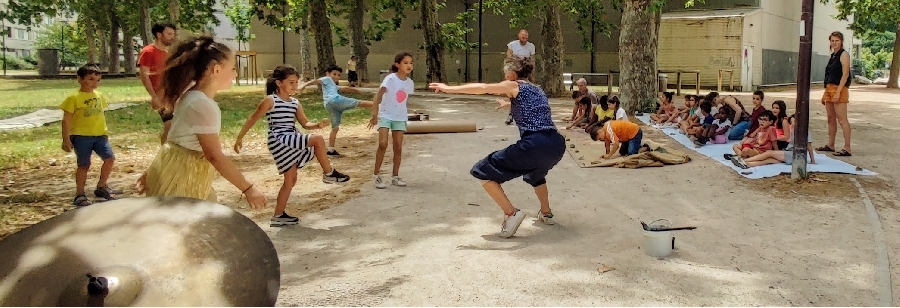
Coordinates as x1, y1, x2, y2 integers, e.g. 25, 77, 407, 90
619, 0, 660, 114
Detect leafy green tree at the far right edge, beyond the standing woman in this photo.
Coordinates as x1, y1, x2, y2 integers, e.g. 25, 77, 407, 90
822, 0, 900, 88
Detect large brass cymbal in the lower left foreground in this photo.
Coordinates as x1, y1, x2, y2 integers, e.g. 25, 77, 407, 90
0, 197, 281, 306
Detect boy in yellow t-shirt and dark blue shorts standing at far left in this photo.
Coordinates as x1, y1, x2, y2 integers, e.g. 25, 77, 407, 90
59, 65, 116, 207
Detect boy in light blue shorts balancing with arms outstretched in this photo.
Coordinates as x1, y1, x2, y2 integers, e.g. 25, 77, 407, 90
297, 65, 373, 156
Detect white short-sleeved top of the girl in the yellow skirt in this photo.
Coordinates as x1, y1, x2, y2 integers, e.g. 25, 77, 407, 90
167, 91, 222, 151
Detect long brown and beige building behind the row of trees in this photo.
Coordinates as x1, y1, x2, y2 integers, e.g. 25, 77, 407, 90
250, 0, 859, 90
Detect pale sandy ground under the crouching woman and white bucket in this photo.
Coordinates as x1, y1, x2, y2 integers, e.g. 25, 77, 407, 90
262, 92, 879, 306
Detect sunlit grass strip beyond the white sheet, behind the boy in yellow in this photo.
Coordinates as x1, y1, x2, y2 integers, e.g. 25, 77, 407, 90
0, 78, 150, 119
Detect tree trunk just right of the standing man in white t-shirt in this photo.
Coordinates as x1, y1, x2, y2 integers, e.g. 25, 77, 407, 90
535, 1, 566, 97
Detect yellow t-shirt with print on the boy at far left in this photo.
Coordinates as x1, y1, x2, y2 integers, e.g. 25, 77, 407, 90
59, 91, 109, 136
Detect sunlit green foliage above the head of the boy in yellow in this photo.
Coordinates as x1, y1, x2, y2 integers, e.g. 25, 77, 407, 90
34, 23, 87, 64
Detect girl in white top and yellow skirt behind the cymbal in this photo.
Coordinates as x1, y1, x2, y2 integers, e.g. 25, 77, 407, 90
137, 36, 266, 209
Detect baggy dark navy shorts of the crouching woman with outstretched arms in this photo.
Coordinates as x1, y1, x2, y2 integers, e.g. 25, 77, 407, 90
470, 130, 566, 187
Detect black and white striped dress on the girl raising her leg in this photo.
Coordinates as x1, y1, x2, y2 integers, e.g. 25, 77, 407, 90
266, 94, 315, 174
